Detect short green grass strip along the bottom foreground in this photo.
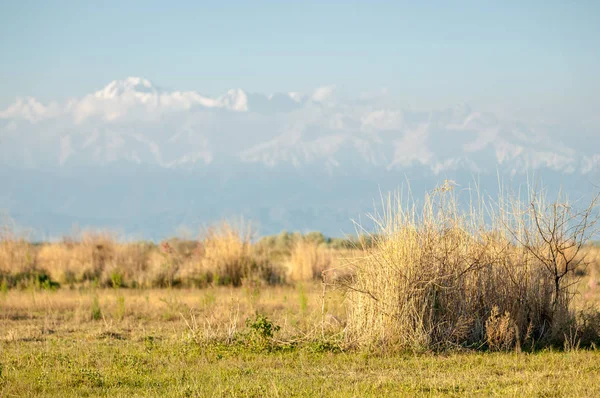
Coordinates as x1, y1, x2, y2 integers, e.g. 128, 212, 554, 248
0, 335, 600, 397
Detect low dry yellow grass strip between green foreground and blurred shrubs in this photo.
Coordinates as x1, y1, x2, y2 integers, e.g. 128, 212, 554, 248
0, 283, 345, 345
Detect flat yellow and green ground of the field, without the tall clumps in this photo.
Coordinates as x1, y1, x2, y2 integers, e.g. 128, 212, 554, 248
0, 283, 600, 397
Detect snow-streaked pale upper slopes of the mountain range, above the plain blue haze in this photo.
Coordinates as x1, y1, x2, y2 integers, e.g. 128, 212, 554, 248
0, 77, 600, 174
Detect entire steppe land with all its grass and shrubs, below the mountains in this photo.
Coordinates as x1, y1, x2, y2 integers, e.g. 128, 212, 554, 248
0, 187, 600, 397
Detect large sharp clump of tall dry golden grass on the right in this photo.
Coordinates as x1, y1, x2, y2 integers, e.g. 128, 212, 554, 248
345, 184, 595, 349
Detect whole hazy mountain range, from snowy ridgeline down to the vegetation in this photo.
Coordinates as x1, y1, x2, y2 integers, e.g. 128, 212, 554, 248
0, 77, 600, 238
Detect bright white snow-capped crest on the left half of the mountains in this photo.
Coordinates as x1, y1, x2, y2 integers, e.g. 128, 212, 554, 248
0, 77, 333, 123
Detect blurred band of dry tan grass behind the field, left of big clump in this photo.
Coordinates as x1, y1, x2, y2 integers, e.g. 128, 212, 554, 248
0, 222, 349, 288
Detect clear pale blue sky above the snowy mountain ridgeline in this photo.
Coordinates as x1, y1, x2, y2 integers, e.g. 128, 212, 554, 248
0, 0, 600, 115
